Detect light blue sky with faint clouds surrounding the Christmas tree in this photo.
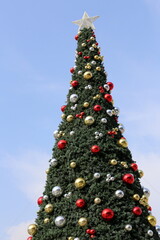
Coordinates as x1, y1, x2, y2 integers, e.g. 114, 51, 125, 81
0, 0, 160, 240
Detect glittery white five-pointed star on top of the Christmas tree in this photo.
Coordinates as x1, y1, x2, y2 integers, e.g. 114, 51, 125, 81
73, 12, 99, 30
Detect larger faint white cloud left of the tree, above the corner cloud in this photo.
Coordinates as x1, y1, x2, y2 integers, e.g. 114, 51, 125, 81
5, 151, 50, 202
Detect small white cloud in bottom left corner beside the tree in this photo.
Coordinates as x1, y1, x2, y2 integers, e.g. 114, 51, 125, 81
7, 220, 34, 240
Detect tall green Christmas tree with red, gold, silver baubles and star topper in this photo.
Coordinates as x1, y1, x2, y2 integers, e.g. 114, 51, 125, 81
28, 14, 160, 240
